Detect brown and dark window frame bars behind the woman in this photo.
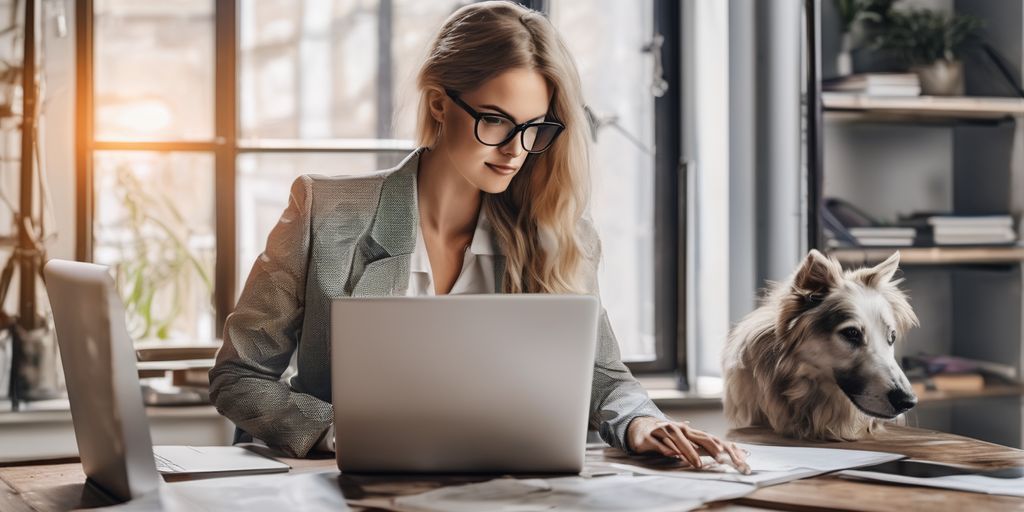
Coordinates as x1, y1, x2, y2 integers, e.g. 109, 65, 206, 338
75, 0, 688, 389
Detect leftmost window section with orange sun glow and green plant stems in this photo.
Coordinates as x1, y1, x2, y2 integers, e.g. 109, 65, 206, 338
88, 0, 217, 340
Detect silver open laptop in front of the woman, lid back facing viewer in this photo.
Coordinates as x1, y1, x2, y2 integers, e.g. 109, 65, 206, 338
331, 295, 599, 473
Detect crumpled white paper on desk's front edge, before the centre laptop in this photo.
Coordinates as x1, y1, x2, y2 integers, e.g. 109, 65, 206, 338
385, 475, 755, 512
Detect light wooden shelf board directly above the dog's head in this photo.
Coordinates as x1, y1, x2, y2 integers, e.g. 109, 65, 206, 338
828, 246, 1024, 265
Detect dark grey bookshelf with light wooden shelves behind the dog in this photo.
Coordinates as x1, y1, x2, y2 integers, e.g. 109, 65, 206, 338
807, 0, 1024, 447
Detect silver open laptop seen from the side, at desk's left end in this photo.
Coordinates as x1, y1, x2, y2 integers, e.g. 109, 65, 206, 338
43, 259, 290, 500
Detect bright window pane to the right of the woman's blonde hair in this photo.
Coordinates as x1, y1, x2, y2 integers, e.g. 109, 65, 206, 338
551, 0, 656, 361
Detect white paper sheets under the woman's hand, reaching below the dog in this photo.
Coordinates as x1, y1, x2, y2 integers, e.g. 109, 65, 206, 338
589, 442, 905, 486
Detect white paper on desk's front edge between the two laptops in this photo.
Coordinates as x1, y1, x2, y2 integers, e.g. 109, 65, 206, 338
77, 469, 349, 512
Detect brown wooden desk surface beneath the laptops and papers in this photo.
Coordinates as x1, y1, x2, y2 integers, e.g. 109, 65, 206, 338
0, 426, 1024, 512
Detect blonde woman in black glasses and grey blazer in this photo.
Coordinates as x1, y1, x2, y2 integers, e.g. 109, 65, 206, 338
210, 1, 742, 467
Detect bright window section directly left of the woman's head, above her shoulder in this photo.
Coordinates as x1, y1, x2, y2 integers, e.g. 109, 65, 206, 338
236, 0, 462, 293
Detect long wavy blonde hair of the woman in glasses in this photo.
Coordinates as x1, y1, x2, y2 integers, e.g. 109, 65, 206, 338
417, 1, 590, 293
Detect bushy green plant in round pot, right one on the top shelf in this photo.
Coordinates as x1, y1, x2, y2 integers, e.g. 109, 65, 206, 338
876, 9, 983, 96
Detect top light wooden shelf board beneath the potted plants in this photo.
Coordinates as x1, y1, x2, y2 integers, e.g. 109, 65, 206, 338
821, 92, 1024, 121
